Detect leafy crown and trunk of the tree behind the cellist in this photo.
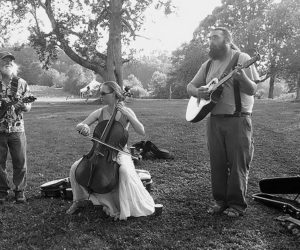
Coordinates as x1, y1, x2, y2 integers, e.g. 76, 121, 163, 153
0, 0, 173, 85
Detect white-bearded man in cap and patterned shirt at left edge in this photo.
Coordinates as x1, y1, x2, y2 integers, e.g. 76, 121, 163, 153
0, 51, 35, 204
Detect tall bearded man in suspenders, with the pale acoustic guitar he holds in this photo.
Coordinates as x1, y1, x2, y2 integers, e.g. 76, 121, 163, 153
186, 27, 259, 217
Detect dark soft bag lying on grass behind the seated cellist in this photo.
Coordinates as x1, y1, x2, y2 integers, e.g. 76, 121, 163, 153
132, 141, 174, 160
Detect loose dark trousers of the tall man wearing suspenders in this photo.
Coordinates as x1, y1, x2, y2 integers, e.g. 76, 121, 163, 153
207, 116, 254, 212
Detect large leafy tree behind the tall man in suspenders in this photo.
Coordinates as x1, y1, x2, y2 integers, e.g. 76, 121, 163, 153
169, 0, 300, 98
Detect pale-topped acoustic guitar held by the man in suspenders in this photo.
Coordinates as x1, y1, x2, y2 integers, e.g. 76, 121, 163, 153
185, 54, 260, 123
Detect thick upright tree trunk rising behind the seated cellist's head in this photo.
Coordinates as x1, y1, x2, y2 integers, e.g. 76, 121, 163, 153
105, 0, 123, 87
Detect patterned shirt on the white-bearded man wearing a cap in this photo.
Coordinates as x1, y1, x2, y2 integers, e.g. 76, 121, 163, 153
0, 78, 31, 133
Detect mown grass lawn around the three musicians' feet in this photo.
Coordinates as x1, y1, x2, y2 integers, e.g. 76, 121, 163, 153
0, 100, 300, 249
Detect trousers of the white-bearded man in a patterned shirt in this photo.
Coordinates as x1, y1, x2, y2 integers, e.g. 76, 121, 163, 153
0, 132, 27, 192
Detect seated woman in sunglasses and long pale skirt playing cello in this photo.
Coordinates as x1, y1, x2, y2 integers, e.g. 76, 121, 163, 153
67, 81, 155, 220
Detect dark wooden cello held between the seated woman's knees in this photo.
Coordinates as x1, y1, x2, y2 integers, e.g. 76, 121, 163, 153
75, 91, 137, 194
